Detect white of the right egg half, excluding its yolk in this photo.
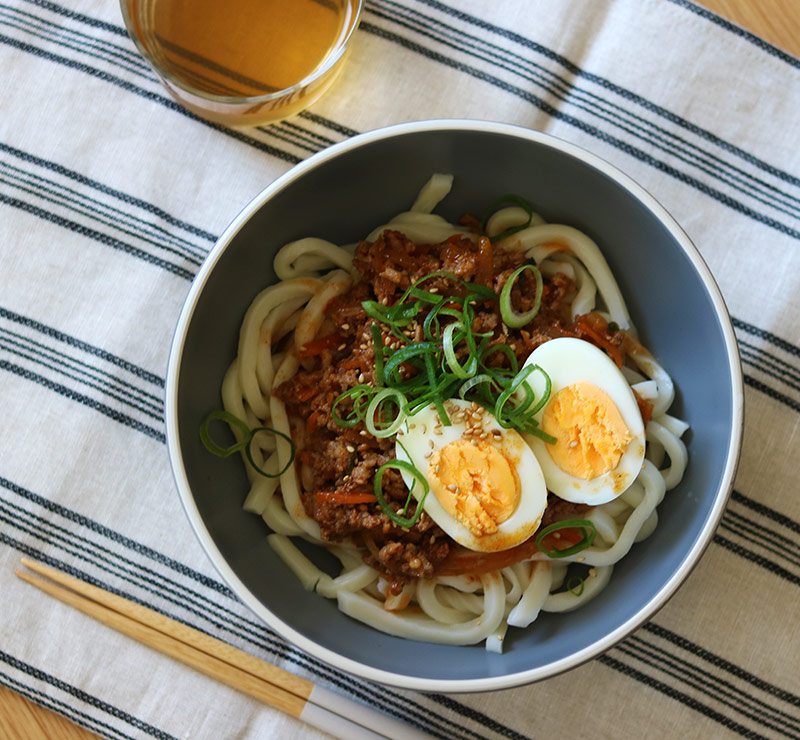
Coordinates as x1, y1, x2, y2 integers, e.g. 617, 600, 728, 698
525, 337, 645, 505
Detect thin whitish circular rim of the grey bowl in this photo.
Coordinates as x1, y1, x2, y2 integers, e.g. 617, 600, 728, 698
165, 118, 744, 693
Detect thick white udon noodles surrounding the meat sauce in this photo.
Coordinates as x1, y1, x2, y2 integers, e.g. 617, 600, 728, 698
211, 175, 688, 651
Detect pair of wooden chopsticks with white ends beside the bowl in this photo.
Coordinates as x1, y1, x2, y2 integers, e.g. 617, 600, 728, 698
16, 558, 427, 740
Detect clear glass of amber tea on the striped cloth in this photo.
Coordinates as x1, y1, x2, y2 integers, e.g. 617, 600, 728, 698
120, 0, 363, 126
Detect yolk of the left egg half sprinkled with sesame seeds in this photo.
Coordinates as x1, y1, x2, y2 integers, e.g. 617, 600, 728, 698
428, 439, 520, 537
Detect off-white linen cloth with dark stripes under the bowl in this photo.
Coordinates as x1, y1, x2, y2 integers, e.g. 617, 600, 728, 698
0, 0, 800, 740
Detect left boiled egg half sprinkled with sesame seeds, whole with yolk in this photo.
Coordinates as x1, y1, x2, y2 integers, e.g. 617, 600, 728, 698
395, 399, 547, 552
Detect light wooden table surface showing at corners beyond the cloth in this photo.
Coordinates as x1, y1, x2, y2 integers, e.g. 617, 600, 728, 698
0, 0, 800, 740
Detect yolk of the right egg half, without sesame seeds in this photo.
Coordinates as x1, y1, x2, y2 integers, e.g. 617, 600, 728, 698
542, 383, 633, 480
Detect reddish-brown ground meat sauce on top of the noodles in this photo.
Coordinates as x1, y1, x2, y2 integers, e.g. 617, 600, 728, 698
275, 230, 636, 593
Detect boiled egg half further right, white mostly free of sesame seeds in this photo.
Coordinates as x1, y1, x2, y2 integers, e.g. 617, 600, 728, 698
525, 337, 645, 505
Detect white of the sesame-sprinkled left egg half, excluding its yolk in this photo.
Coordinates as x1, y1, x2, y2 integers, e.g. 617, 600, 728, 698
395, 399, 547, 552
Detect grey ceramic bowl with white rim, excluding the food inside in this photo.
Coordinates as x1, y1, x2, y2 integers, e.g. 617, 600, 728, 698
166, 121, 743, 692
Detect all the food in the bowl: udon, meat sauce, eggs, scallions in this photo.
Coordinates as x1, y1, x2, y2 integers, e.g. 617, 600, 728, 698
201, 175, 688, 652
